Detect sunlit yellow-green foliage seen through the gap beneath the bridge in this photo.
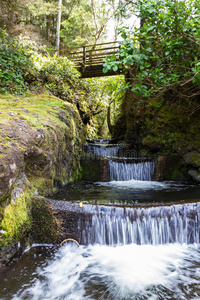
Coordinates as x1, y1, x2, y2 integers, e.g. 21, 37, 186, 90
79, 76, 124, 138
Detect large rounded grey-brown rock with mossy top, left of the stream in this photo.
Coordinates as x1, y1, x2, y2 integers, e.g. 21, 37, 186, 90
0, 95, 83, 206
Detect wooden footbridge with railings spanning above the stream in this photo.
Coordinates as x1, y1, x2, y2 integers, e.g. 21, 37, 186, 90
56, 42, 123, 78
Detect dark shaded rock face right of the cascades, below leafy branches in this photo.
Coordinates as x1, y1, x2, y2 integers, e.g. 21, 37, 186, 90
114, 91, 200, 182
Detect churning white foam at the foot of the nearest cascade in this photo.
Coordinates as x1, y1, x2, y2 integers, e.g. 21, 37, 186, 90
13, 244, 200, 300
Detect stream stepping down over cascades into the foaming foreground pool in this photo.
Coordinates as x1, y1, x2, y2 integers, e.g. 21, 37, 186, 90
0, 144, 200, 300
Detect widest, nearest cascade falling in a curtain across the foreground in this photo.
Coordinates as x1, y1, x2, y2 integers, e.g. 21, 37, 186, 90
78, 203, 200, 246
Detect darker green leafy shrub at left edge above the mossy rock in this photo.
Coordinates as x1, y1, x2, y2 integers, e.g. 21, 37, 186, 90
0, 30, 34, 92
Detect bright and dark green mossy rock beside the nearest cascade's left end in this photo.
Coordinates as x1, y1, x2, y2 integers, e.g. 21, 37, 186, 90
0, 190, 61, 250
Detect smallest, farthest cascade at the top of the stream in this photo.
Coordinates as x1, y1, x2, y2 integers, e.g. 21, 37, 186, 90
87, 144, 119, 156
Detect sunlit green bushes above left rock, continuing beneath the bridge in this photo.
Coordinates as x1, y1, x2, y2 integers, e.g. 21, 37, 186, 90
0, 28, 124, 137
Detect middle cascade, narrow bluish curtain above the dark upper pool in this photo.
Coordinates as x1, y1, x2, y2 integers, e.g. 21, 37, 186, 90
109, 160, 155, 181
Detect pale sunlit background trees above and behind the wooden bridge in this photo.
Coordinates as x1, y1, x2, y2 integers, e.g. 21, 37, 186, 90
0, 0, 119, 48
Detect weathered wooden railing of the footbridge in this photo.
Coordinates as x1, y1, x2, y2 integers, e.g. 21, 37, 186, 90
55, 42, 119, 69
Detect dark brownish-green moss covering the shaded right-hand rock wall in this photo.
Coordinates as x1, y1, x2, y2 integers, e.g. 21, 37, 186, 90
122, 91, 200, 154
